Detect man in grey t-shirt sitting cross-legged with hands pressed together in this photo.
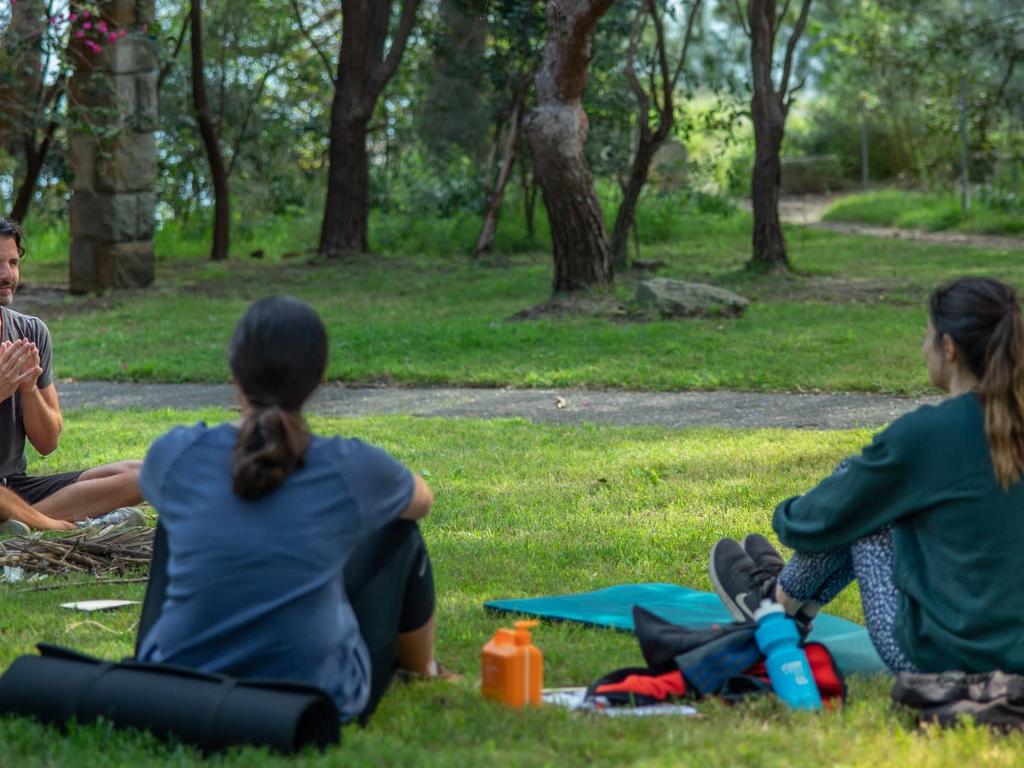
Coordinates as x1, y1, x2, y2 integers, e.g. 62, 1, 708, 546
0, 218, 142, 527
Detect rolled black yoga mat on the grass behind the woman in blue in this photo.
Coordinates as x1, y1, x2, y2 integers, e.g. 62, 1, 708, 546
0, 644, 341, 753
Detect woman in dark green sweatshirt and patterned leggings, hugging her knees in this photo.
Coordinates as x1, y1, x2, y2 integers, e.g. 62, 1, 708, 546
709, 278, 1024, 673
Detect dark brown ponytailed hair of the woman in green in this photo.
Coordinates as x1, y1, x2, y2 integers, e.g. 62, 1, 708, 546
929, 278, 1024, 488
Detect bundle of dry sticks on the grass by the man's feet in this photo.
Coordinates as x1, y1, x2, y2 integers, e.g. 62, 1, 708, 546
0, 525, 156, 575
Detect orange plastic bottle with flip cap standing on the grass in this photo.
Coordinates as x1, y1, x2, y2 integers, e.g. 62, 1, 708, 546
480, 621, 544, 708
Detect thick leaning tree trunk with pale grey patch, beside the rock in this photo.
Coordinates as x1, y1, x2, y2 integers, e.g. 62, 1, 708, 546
526, 0, 613, 294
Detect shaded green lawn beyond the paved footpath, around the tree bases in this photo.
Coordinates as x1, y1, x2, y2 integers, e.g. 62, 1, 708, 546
14, 211, 1024, 393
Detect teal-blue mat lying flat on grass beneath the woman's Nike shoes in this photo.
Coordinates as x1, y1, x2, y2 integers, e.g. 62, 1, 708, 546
483, 584, 889, 675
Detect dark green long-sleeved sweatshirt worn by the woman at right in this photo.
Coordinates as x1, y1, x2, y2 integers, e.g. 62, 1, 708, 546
772, 393, 1024, 674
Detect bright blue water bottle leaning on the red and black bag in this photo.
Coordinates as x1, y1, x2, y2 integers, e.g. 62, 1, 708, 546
754, 600, 821, 710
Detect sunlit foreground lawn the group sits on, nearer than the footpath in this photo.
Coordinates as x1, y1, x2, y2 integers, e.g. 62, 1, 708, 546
0, 411, 1024, 768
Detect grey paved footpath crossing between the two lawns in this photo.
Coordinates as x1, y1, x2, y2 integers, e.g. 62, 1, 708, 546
57, 382, 940, 429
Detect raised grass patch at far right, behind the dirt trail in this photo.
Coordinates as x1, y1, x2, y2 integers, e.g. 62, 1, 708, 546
823, 189, 1024, 234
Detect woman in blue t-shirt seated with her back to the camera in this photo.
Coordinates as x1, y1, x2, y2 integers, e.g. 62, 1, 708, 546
137, 297, 437, 721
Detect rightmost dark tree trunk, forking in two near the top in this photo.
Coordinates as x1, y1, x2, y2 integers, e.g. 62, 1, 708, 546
746, 0, 811, 272
